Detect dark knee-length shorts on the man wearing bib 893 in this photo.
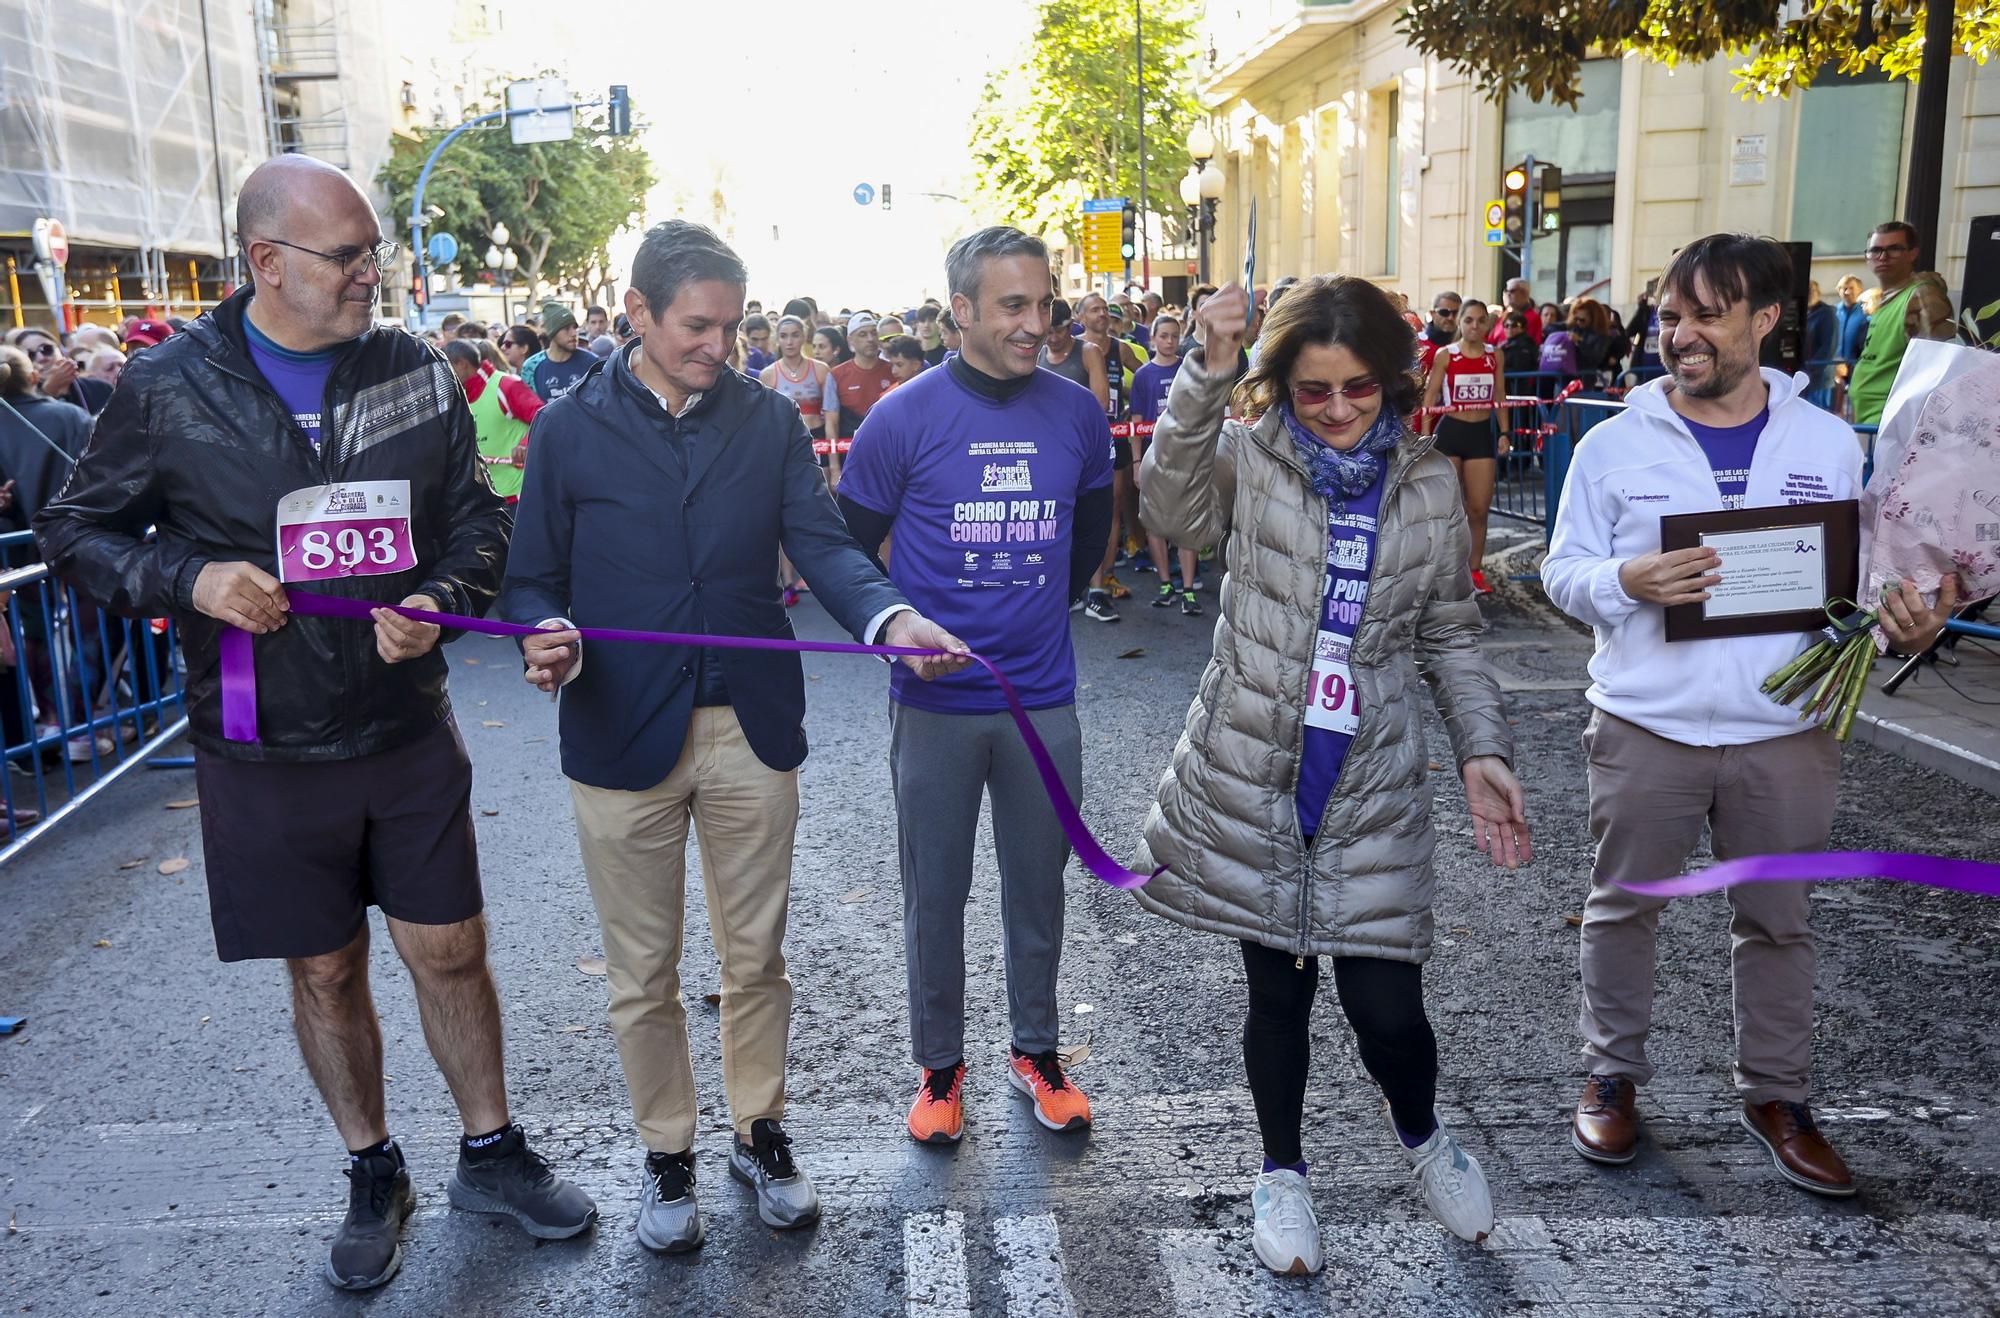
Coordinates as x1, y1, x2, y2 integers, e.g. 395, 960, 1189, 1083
194, 720, 486, 962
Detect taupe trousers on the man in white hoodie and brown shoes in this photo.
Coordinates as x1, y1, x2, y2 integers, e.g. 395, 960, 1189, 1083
1578, 710, 1840, 1102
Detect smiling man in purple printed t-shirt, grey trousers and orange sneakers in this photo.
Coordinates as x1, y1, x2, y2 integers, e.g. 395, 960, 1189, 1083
840, 226, 1112, 1142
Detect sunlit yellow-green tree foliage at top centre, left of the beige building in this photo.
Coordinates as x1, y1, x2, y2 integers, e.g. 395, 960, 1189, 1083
972, 0, 1200, 240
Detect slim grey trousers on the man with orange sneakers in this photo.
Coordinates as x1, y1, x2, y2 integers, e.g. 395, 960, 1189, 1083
888, 702, 1084, 1066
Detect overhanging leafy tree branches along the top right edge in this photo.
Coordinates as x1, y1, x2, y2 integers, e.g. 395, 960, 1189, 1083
1398, 0, 2000, 106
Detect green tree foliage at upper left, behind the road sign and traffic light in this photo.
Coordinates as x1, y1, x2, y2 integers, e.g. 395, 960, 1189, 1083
382, 88, 656, 298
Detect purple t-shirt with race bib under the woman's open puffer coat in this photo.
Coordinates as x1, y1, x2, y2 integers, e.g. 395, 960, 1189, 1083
1296, 468, 1386, 838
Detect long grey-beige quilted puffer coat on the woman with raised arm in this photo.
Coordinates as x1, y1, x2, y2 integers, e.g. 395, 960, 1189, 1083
1134, 350, 1514, 962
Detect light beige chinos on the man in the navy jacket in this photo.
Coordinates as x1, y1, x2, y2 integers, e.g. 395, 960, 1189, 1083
570, 706, 798, 1154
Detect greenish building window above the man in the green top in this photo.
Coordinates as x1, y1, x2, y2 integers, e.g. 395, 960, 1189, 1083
1792, 68, 1908, 256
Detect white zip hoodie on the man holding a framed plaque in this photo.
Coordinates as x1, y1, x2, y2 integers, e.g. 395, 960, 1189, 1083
1542, 370, 1862, 746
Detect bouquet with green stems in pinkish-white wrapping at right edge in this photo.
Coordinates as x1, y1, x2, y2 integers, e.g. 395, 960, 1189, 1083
1764, 342, 2000, 740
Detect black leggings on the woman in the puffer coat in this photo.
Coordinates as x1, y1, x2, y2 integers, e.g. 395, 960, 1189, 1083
1244, 942, 1438, 1166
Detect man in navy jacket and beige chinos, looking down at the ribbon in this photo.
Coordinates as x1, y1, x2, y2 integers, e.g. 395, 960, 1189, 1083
500, 220, 968, 1252
